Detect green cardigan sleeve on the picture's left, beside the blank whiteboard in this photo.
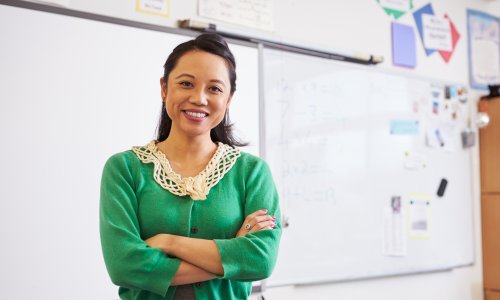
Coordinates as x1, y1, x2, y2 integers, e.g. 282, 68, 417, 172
99, 152, 180, 296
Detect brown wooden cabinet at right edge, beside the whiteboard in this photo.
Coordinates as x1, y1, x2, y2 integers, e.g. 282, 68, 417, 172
479, 97, 500, 300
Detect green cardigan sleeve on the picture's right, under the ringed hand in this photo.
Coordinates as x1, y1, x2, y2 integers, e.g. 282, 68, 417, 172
215, 159, 281, 281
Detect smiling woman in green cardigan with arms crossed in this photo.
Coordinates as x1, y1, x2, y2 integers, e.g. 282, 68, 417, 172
100, 34, 281, 299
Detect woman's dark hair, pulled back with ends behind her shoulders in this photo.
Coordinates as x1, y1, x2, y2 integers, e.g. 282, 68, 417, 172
156, 33, 248, 147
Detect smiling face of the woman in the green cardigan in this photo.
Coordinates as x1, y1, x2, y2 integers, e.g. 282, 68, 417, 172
160, 51, 231, 137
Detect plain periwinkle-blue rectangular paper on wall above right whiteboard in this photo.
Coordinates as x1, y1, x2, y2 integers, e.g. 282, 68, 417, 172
391, 22, 417, 68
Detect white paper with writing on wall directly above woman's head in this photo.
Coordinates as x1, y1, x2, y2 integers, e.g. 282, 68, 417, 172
198, 0, 274, 31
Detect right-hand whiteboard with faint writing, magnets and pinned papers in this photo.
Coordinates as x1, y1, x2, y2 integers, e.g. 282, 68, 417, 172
263, 48, 474, 286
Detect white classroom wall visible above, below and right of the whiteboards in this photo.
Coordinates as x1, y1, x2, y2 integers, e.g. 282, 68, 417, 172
15, 0, 500, 300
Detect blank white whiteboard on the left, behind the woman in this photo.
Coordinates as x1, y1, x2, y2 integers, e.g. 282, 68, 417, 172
0, 5, 259, 299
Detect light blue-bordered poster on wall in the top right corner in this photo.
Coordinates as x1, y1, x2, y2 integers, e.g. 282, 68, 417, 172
467, 9, 500, 90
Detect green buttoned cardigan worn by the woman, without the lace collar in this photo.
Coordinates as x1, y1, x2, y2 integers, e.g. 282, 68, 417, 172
100, 150, 281, 300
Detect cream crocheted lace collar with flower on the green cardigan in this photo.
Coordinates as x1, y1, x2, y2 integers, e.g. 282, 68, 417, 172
132, 140, 240, 200
